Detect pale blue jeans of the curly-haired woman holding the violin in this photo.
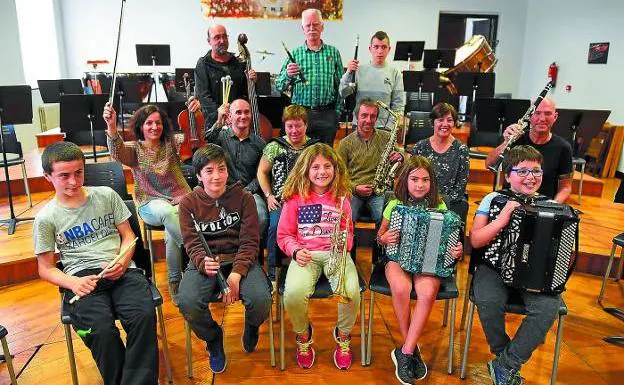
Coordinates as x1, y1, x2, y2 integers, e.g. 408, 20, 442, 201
139, 199, 182, 282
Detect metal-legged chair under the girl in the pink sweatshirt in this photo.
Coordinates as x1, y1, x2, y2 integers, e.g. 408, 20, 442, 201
276, 243, 366, 370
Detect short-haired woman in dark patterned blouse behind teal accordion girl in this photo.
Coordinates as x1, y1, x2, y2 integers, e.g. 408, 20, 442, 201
409, 103, 470, 222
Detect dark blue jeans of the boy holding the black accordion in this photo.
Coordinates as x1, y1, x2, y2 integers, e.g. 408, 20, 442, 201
473, 265, 561, 370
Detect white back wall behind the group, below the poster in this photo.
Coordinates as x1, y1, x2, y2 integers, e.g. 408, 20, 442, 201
60, 0, 526, 93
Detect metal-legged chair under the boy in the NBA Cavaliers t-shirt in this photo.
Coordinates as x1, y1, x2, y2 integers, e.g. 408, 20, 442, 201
59, 200, 173, 385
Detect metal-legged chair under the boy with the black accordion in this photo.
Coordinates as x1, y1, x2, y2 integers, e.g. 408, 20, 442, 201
459, 272, 568, 385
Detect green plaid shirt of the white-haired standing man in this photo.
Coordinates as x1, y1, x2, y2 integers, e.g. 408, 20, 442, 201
276, 43, 344, 113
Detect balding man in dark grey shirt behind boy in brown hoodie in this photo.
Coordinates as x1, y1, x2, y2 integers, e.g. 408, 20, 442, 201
205, 99, 269, 232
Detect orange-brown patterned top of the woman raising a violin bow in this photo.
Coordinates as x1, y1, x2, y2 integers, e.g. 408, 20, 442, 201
106, 133, 191, 206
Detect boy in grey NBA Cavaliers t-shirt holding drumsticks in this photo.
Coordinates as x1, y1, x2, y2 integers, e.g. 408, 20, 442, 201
33, 142, 158, 385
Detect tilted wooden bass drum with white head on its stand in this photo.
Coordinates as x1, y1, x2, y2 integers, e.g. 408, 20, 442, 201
444, 35, 496, 94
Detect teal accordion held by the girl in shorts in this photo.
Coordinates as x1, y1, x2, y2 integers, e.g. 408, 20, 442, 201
386, 205, 461, 278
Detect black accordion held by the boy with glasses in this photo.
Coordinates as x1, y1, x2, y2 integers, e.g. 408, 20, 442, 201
481, 193, 579, 294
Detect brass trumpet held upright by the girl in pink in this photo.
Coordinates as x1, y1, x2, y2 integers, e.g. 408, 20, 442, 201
326, 197, 351, 303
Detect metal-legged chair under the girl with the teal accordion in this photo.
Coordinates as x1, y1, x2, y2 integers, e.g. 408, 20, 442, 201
366, 246, 459, 374
